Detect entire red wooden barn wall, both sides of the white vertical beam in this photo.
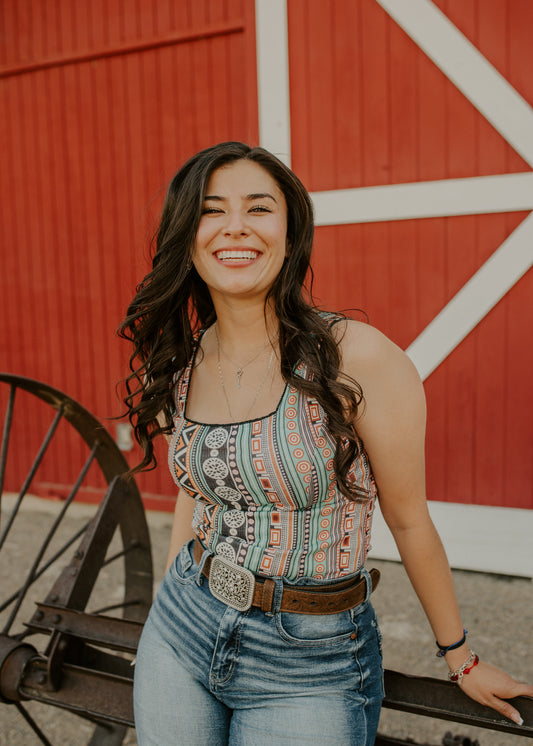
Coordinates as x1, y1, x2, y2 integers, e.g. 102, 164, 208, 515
0, 0, 533, 508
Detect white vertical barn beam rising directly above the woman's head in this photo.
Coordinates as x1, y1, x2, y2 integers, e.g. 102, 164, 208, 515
255, 0, 291, 166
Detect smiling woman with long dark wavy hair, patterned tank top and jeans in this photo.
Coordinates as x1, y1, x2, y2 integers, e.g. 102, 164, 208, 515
121, 143, 533, 746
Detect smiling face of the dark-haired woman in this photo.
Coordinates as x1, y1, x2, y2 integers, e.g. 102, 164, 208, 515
193, 160, 287, 303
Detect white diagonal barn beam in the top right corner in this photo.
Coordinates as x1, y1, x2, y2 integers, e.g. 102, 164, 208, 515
376, 0, 533, 166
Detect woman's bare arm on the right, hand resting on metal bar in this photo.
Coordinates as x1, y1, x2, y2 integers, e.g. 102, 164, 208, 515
341, 322, 533, 723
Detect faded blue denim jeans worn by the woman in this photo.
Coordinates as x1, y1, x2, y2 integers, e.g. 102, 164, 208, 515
134, 542, 383, 746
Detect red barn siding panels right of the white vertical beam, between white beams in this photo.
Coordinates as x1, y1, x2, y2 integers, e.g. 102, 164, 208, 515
288, 0, 533, 507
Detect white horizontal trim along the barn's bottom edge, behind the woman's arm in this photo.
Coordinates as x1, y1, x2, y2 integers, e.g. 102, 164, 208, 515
369, 500, 533, 578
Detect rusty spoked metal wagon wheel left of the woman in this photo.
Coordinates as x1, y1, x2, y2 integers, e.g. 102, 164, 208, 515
0, 373, 152, 746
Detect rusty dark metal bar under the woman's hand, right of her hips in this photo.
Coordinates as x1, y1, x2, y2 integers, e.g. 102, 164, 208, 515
383, 670, 533, 738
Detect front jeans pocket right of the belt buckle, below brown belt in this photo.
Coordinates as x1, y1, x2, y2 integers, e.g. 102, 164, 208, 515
275, 611, 357, 647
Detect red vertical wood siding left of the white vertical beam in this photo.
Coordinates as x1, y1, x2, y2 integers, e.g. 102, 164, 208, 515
0, 0, 258, 506
